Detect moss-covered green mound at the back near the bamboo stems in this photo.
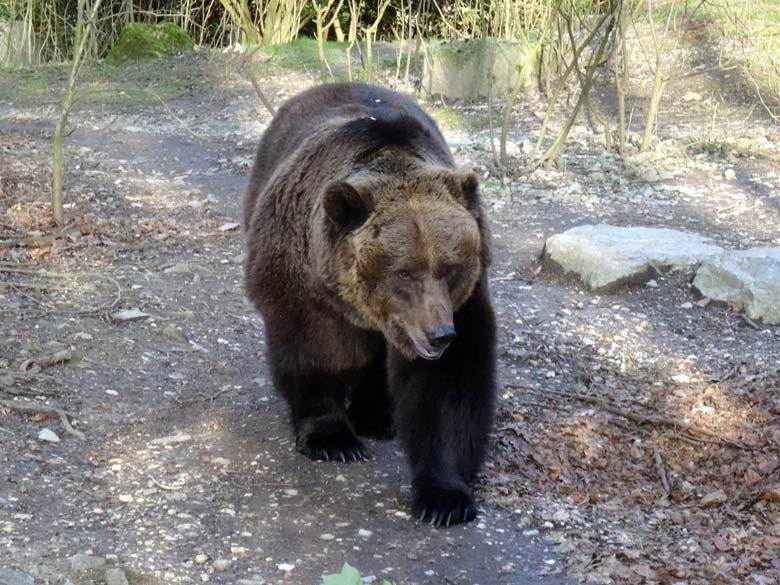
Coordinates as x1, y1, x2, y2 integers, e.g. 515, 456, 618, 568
106, 22, 192, 65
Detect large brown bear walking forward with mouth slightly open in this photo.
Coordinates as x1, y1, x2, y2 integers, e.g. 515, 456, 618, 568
244, 83, 496, 526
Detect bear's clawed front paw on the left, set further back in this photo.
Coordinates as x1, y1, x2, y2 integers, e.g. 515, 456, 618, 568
295, 419, 368, 463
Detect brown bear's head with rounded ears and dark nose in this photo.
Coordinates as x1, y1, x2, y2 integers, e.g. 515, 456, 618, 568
321, 168, 488, 360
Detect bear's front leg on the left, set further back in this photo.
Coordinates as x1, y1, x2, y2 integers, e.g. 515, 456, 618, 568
271, 358, 368, 463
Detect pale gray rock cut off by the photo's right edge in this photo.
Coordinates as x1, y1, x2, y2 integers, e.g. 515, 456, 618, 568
693, 248, 780, 325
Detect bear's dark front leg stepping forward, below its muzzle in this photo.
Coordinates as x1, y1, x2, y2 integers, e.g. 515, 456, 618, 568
388, 277, 496, 526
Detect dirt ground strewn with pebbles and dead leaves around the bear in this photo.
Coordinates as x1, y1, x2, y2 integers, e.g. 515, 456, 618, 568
0, 36, 780, 585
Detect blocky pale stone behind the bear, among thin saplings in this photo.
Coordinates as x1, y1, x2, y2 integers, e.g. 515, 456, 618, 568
422, 39, 535, 102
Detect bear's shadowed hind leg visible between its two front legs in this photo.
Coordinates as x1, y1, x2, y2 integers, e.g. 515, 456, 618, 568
347, 351, 395, 440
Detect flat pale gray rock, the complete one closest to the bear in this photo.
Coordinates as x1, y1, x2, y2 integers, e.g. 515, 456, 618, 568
544, 224, 723, 290
